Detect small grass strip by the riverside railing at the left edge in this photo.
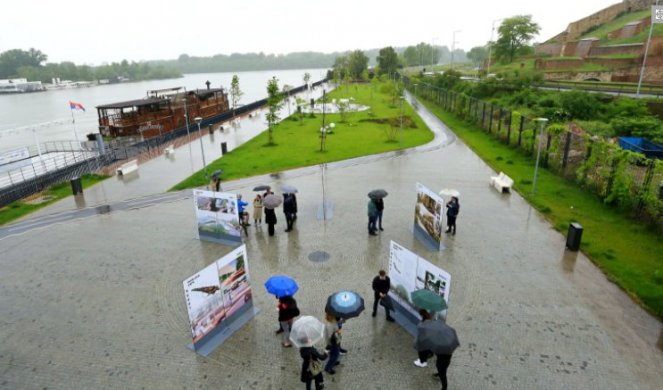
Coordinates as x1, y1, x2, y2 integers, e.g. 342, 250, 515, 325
0, 174, 109, 225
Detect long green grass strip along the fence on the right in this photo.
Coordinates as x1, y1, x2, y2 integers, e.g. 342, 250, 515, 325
418, 95, 663, 318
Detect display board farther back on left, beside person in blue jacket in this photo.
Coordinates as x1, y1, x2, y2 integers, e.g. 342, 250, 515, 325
193, 190, 242, 246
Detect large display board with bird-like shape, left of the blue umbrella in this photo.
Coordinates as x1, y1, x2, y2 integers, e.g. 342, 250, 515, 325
182, 245, 257, 356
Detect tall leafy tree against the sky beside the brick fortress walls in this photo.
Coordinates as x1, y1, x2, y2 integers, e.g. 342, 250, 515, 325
493, 15, 541, 62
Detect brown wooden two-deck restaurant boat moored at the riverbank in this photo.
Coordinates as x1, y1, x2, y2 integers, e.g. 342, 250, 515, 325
96, 81, 229, 138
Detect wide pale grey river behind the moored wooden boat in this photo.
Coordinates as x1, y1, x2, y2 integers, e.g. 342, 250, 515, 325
0, 69, 326, 154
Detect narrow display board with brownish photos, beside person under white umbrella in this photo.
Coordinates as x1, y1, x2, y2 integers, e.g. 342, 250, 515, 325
414, 183, 444, 250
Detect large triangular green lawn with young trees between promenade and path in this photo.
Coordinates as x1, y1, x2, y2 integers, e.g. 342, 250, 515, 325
171, 84, 433, 190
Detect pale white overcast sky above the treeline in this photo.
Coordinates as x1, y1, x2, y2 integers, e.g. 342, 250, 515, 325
0, 0, 620, 65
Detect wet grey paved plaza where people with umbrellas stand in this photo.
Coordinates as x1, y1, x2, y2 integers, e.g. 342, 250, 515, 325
0, 95, 663, 389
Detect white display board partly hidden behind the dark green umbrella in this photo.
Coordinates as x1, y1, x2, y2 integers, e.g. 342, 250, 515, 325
389, 241, 451, 333
